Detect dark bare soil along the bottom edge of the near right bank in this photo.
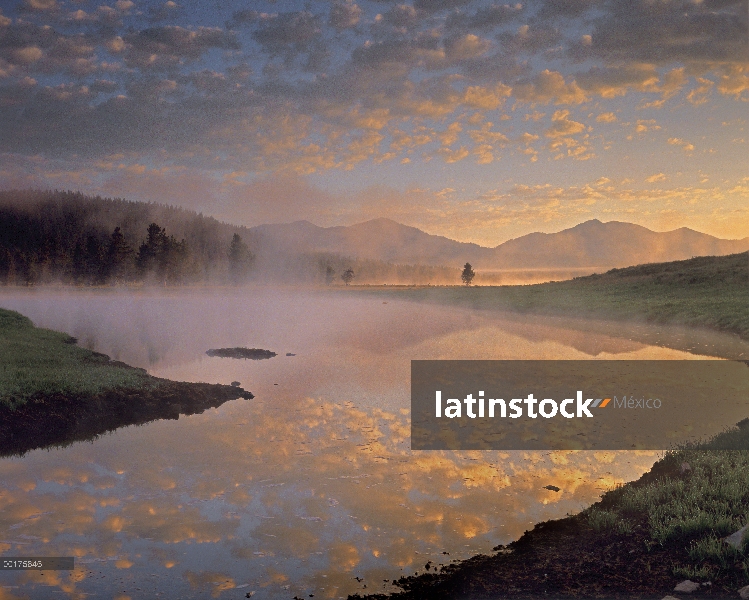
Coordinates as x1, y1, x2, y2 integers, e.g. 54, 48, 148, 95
349, 515, 737, 600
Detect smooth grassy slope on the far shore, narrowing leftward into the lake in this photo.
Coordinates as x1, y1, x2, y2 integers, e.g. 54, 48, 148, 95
352, 252, 749, 340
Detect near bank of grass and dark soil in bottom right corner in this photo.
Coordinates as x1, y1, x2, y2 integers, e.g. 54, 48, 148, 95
350, 423, 749, 600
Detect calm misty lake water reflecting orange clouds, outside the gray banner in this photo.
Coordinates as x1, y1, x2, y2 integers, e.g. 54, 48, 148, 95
0, 289, 737, 600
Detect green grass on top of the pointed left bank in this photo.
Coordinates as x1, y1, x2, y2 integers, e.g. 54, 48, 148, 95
0, 309, 154, 409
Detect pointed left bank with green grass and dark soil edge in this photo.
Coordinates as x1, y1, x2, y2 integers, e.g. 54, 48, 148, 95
0, 309, 252, 455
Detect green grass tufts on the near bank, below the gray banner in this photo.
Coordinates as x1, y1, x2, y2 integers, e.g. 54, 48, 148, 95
583, 423, 749, 581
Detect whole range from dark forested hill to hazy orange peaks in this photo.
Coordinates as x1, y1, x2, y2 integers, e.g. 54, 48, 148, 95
0, 190, 749, 284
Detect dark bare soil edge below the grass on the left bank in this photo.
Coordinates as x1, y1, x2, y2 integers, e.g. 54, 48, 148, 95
0, 377, 253, 456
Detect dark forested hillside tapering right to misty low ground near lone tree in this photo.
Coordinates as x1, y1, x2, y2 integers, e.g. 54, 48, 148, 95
0, 190, 459, 285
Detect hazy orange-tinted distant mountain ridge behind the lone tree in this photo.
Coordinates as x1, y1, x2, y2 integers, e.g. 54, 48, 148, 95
250, 218, 749, 269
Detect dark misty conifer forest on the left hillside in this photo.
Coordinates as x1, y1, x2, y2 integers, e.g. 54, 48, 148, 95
0, 192, 255, 285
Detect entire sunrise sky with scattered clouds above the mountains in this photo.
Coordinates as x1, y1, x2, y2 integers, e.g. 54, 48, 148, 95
0, 0, 749, 246
